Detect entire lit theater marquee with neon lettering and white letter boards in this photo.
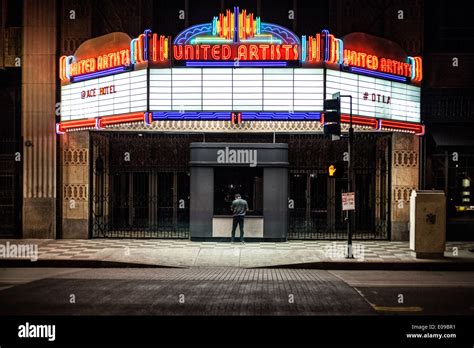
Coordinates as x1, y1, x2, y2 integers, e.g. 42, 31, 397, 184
58, 7, 423, 133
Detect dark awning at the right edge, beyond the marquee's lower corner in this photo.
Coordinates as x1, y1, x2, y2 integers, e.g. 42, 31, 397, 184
426, 125, 474, 147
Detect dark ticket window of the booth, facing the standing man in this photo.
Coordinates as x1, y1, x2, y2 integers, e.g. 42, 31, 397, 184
214, 167, 263, 216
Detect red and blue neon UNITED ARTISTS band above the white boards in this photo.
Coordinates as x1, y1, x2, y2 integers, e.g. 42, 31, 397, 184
59, 7, 423, 83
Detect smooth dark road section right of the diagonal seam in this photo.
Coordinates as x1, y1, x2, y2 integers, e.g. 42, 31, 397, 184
330, 270, 474, 315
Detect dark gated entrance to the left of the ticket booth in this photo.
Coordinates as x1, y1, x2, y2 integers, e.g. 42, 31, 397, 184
90, 132, 190, 238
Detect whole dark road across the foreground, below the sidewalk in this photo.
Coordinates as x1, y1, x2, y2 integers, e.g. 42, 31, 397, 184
0, 268, 474, 315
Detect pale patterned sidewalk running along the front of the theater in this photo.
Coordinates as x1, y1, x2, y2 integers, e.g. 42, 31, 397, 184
0, 239, 474, 270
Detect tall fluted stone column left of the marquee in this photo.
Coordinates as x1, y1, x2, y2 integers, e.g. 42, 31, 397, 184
21, 0, 56, 238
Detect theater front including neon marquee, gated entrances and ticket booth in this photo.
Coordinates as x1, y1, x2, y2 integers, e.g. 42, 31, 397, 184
56, 7, 424, 241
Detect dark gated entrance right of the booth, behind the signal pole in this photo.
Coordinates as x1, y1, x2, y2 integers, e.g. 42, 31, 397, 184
288, 134, 390, 240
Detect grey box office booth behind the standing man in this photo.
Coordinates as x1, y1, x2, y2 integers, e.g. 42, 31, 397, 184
190, 143, 288, 241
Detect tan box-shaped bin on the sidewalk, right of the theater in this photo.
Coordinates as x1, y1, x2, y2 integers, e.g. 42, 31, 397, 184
410, 190, 446, 259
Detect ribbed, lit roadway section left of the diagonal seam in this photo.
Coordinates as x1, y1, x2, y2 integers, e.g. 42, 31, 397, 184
0, 267, 375, 316
